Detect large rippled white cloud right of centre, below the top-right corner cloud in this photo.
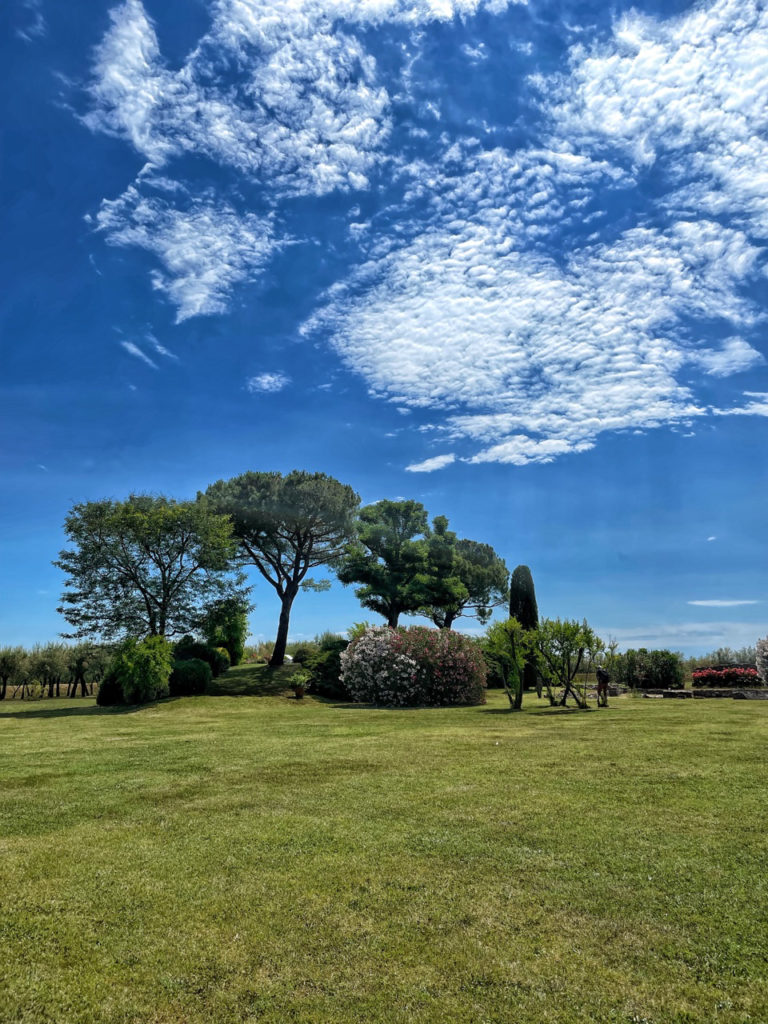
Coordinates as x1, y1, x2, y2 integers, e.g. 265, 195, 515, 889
306, 202, 759, 465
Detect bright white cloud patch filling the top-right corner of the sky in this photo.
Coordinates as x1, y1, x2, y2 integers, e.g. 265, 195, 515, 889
544, 0, 768, 236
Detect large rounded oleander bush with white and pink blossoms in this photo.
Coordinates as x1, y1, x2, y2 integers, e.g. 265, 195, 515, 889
341, 626, 485, 707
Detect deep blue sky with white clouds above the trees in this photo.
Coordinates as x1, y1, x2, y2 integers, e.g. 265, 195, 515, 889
0, 0, 768, 652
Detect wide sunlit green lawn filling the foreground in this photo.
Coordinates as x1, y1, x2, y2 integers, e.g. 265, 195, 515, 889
0, 669, 768, 1024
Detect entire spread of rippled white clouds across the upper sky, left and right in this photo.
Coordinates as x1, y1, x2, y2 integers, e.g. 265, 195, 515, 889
84, 0, 768, 471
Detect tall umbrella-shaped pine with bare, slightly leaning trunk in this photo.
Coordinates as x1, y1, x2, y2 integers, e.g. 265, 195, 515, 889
204, 470, 360, 666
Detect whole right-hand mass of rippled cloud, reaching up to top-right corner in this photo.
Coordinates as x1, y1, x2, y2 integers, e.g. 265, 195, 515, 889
306, 0, 768, 465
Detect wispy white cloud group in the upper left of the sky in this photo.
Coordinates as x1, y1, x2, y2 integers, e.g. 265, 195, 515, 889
83, 0, 525, 319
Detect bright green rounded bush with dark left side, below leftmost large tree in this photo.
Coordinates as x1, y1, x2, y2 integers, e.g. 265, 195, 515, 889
96, 637, 173, 707
